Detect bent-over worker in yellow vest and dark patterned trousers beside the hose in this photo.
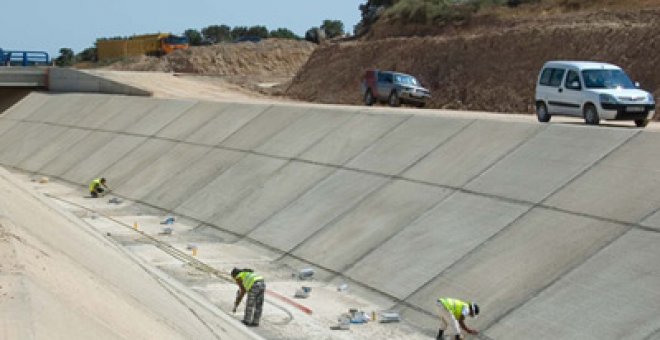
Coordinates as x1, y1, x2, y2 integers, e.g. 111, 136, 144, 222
231, 268, 266, 327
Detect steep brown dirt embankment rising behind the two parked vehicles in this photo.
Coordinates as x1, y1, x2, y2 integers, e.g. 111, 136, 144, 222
286, 9, 660, 113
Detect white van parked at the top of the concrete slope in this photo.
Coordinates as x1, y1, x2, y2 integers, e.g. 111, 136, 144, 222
535, 61, 655, 127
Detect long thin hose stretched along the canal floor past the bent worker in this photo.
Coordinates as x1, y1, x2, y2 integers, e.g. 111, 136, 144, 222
44, 193, 296, 326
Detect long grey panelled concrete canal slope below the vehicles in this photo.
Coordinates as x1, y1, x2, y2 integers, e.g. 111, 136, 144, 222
0, 94, 660, 339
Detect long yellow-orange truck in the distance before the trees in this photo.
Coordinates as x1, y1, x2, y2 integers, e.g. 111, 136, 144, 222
96, 33, 189, 61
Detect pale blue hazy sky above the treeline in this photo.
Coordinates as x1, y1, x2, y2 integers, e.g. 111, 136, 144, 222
0, 0, 366, 58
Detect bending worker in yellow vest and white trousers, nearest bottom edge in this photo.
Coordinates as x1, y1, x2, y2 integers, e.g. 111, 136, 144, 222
436, 298, 479, 339
